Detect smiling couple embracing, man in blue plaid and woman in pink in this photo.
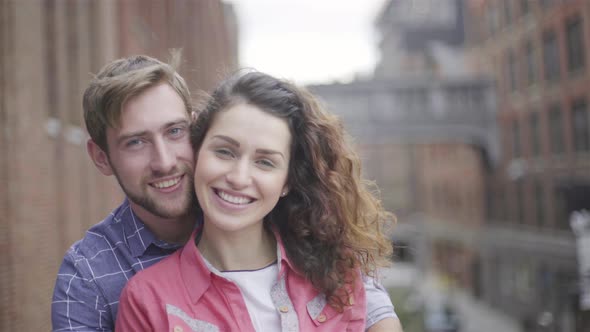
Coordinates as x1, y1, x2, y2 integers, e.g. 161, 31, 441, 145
52, 56, 401, 331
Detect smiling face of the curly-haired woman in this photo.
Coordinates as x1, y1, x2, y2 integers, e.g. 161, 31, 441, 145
195, 104, 291, 232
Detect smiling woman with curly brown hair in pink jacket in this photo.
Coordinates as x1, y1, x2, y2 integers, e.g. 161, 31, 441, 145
117, 72, 393, 331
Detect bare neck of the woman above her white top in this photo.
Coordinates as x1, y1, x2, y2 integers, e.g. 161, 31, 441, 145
197, 224, 277, 271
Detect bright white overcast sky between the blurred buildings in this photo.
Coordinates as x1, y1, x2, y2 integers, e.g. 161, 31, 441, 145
225, 0, 385, 84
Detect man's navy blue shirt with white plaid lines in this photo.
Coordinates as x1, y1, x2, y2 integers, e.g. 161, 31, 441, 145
51, 200, 396, 331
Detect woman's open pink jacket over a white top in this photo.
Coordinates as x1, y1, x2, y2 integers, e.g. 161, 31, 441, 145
116, 230, 366, 332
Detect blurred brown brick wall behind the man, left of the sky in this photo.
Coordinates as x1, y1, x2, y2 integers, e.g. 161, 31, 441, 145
0, 0, 237, 331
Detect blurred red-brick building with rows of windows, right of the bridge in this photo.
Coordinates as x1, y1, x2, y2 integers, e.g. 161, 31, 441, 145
465, 0, 590, 331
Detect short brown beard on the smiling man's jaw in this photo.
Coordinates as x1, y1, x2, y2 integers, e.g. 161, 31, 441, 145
113, 168, 198, 219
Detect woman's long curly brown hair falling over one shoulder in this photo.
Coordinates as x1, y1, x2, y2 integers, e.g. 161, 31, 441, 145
191, 72, 394, 310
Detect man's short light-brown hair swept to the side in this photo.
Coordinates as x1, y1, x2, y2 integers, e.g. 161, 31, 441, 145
82, 53, 193, 153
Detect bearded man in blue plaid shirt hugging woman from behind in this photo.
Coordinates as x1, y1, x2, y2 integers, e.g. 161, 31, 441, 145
51, 56, 401, 332
